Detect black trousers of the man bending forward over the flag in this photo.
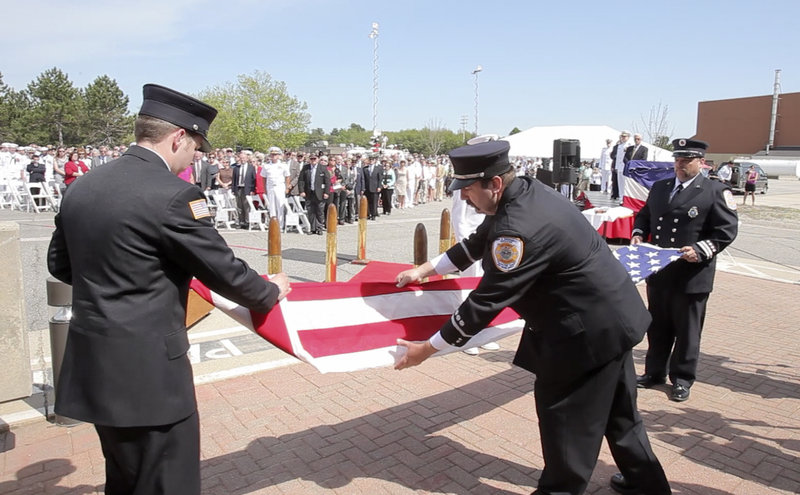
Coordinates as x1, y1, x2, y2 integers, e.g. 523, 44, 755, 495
534, 351, 671, 495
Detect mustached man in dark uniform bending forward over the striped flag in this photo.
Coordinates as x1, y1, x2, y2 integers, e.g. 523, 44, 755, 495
395, 141, 670, 494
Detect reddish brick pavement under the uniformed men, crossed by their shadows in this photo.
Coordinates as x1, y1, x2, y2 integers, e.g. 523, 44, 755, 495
0, 273, 800, 495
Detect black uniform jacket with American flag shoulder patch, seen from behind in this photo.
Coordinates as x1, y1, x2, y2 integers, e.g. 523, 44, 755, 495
48, 146, 278, 427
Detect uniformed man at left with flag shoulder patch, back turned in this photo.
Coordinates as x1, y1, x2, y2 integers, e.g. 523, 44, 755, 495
48, 84, 290, 495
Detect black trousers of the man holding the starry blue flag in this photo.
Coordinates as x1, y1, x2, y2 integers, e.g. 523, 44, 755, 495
644, 284, 708, 388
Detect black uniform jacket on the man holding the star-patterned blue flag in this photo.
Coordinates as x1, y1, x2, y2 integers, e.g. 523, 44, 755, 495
633, 174, 738, 294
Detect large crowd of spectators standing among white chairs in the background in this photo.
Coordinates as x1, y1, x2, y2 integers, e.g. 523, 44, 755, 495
0, 143, 556, 228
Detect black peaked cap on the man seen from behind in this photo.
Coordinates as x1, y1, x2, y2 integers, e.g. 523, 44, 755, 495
139, 84, 217, 153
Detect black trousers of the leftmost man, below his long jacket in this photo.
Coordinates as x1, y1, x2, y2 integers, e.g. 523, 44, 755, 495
95, 411, 200, 495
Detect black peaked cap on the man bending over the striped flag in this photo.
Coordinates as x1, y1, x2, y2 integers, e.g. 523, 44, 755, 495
449, 141, 511, 191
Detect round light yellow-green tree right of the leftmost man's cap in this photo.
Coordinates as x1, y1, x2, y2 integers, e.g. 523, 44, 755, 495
199, 71, 311, 150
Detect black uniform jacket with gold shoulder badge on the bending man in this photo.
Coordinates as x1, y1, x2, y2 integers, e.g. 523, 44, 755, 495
441, 177, 650, 383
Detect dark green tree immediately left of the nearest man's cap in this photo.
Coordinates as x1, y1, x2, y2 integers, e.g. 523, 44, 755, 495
84, 75, 135, 145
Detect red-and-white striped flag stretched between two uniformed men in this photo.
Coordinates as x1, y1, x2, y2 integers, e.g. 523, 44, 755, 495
191, 274, 523, 373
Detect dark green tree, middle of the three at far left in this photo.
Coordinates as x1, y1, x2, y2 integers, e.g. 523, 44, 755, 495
28, 67, 85, 146
